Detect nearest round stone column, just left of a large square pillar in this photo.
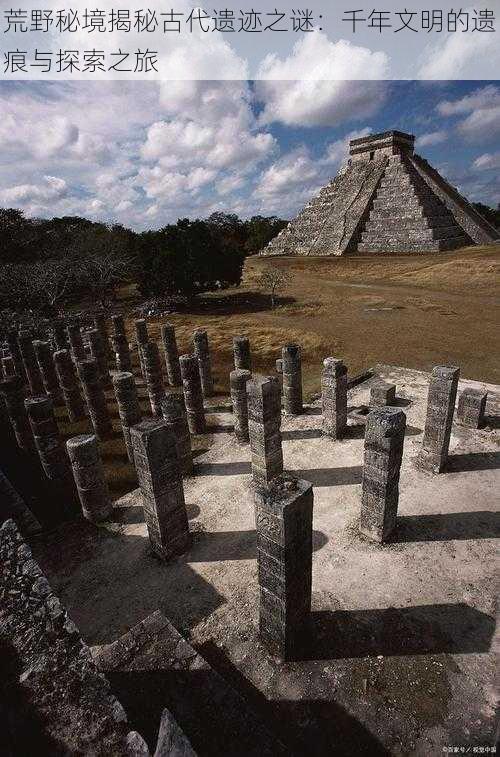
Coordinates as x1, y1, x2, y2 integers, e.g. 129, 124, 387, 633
66, 434, 113, 523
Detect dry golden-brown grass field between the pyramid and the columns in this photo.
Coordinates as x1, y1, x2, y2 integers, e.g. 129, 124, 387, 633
120, 245, 500, 395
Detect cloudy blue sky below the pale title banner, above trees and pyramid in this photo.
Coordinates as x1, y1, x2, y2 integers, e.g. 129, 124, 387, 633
0, 79, 500, 229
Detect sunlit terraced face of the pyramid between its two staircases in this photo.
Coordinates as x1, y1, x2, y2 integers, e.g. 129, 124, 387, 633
357, 155, 472, 253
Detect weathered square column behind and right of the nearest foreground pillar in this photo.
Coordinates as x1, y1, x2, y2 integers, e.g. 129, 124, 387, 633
360, 407, 406, 542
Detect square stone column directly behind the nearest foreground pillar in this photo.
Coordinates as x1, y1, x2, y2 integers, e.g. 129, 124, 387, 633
247, 376, 283, 487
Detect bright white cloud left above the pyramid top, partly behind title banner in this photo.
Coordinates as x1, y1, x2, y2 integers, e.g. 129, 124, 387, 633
255, 32, 388, 126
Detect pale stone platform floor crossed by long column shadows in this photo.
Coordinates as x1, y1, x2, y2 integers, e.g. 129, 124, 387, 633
33, 366, 500, 755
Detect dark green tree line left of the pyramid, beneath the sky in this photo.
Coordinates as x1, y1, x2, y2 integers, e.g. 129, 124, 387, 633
0, 208, 286, 315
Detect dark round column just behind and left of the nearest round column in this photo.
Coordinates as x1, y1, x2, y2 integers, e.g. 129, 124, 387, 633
24, 397, 69, 481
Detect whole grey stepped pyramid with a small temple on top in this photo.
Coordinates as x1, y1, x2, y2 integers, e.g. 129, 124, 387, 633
261, 131, 500, 255
